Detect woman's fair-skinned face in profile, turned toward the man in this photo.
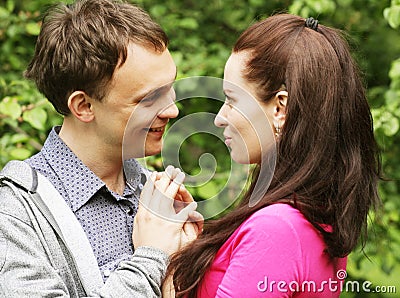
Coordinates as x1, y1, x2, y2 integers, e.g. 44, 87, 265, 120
214, 51, 275, 164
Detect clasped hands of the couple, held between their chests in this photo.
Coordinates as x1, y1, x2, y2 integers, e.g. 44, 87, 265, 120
132, 166, 204, 255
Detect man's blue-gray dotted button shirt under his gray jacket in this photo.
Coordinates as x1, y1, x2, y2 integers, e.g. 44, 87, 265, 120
26, 127, 148, 280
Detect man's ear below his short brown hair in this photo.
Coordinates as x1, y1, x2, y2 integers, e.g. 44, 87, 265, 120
68, 91, 94, 122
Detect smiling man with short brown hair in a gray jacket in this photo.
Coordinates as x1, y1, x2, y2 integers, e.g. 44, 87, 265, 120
0, 0, 195, 297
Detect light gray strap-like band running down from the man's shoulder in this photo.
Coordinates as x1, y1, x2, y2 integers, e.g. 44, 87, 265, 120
0, 161, 104, 296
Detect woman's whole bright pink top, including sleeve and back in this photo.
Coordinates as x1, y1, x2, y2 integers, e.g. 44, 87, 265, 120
198, 204, 347, 297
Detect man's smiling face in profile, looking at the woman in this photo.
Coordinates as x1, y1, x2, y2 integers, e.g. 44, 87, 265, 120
95, 43, 178, 159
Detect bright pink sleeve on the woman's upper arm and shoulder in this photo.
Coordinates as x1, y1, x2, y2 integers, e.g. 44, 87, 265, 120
216, 214, 303, 297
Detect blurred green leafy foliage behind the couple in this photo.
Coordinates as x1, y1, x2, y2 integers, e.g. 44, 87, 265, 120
0, 0, 400, 297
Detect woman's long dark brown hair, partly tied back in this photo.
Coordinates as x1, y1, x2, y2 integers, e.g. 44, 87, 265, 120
168, 14, 380, 297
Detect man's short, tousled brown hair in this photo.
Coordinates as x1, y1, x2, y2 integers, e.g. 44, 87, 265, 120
25, 0, 168, 115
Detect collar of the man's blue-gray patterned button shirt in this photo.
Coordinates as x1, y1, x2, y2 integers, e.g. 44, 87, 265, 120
41, 126, 148, 212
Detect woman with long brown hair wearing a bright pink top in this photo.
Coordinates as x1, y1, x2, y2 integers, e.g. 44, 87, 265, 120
163, 14, 380, 297
